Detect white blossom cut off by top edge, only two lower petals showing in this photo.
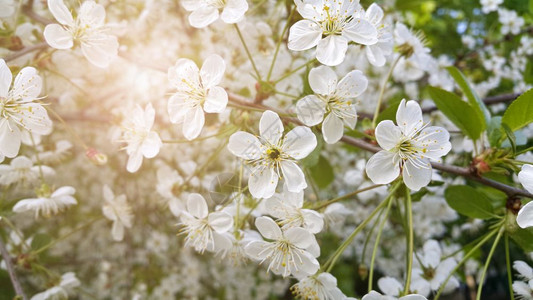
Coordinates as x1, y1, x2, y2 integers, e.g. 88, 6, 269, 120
181, 0, 248, 28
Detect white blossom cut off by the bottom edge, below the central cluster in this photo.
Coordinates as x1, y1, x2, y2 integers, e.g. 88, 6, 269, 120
291, 273, 346, 300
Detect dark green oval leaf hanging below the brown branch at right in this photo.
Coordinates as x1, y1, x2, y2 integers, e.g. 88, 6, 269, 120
444, 185, 496, 219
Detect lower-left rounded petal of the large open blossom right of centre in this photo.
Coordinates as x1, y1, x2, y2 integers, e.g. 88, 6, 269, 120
366, 150, 400, 184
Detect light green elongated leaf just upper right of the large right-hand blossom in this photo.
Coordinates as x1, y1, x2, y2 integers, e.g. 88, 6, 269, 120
428, 86, 485, 140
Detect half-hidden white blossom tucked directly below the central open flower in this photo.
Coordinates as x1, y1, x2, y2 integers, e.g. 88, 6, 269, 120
265, 190, 324, 234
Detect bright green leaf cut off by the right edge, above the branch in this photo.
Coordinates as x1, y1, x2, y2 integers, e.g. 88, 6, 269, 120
502, 89, 533, 131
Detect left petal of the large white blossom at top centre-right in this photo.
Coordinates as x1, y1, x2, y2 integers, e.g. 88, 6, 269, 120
287, 20, 322, 51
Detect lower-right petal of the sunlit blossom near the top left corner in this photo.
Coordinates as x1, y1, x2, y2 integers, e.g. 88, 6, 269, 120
81, 34, 118, 68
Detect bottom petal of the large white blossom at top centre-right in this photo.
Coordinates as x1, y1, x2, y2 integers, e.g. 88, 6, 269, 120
316, 35, 348, 66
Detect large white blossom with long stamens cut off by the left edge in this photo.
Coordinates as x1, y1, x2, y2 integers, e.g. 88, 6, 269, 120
0, 59, 52, 158
